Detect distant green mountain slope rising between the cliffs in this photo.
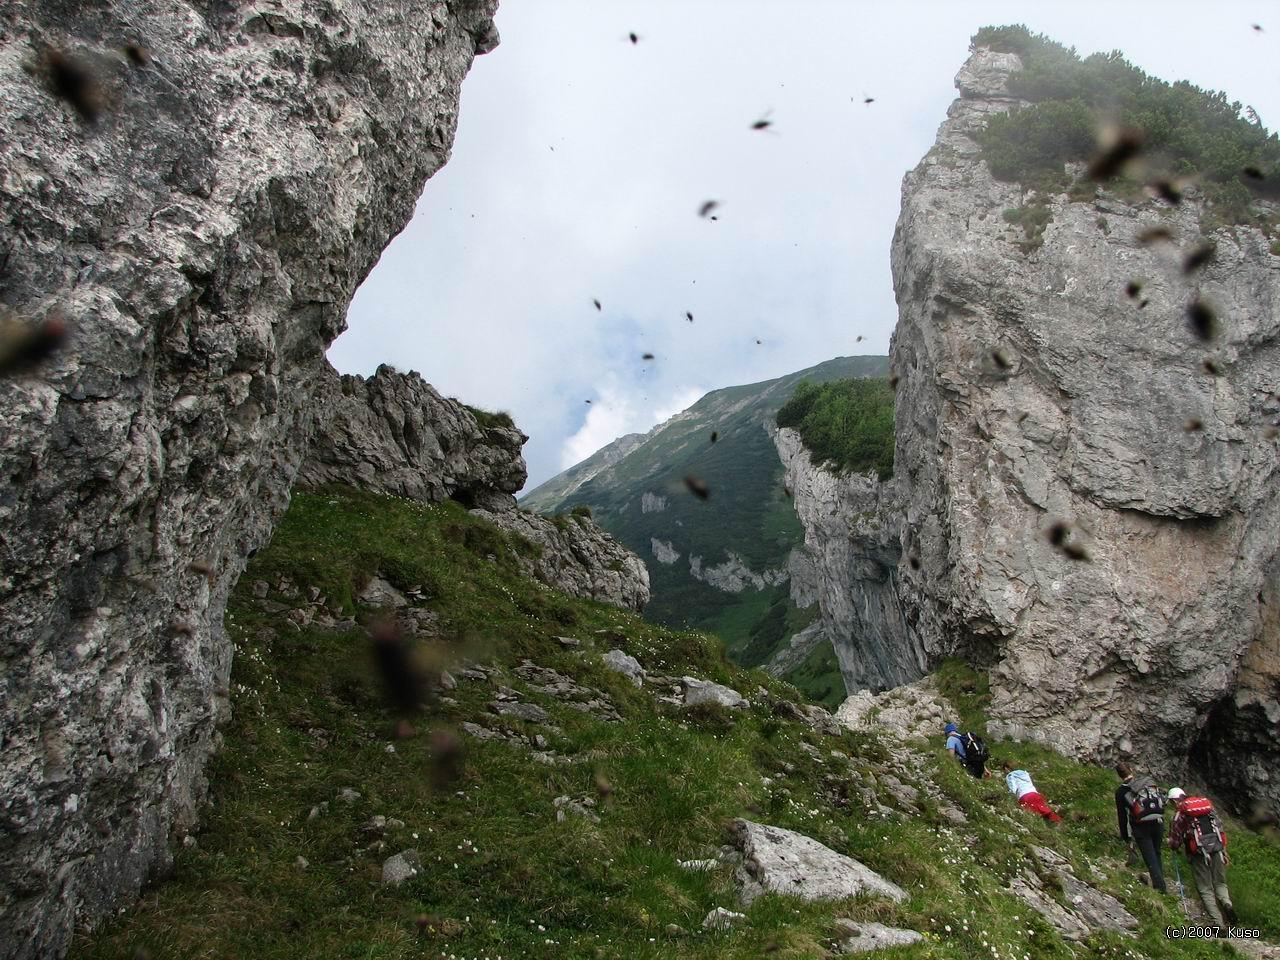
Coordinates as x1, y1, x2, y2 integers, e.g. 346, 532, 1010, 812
521, 357, 888, 701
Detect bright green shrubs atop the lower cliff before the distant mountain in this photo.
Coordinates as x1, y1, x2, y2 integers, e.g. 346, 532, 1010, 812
777, 378, 893, 480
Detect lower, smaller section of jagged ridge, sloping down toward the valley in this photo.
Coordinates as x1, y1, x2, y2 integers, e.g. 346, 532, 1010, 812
471, 509, 649, 611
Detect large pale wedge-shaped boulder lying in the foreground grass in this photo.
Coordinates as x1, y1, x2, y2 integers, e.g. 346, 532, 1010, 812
733, 819, 906, 904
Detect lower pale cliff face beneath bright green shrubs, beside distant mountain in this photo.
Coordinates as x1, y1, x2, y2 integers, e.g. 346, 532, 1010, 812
771, 428, 927, 690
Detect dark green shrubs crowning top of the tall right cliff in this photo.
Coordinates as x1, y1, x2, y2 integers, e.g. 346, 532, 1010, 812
973, 24, 1280, 224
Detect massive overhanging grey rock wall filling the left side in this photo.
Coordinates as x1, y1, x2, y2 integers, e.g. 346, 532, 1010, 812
0, 0, 497, 957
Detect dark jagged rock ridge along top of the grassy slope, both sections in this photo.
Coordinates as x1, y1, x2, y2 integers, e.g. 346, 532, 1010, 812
297, 366, 649, 611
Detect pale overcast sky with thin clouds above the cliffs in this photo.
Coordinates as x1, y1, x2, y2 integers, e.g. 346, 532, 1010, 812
329, 0, 1280, 489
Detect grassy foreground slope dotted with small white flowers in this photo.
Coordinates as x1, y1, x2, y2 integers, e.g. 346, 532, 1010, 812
73, 490, 1280, 960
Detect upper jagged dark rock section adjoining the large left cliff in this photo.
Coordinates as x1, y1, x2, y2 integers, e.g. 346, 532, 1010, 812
297, 366, 529, 509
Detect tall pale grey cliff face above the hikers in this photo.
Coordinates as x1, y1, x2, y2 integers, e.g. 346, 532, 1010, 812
851, 49, 1280, 808
